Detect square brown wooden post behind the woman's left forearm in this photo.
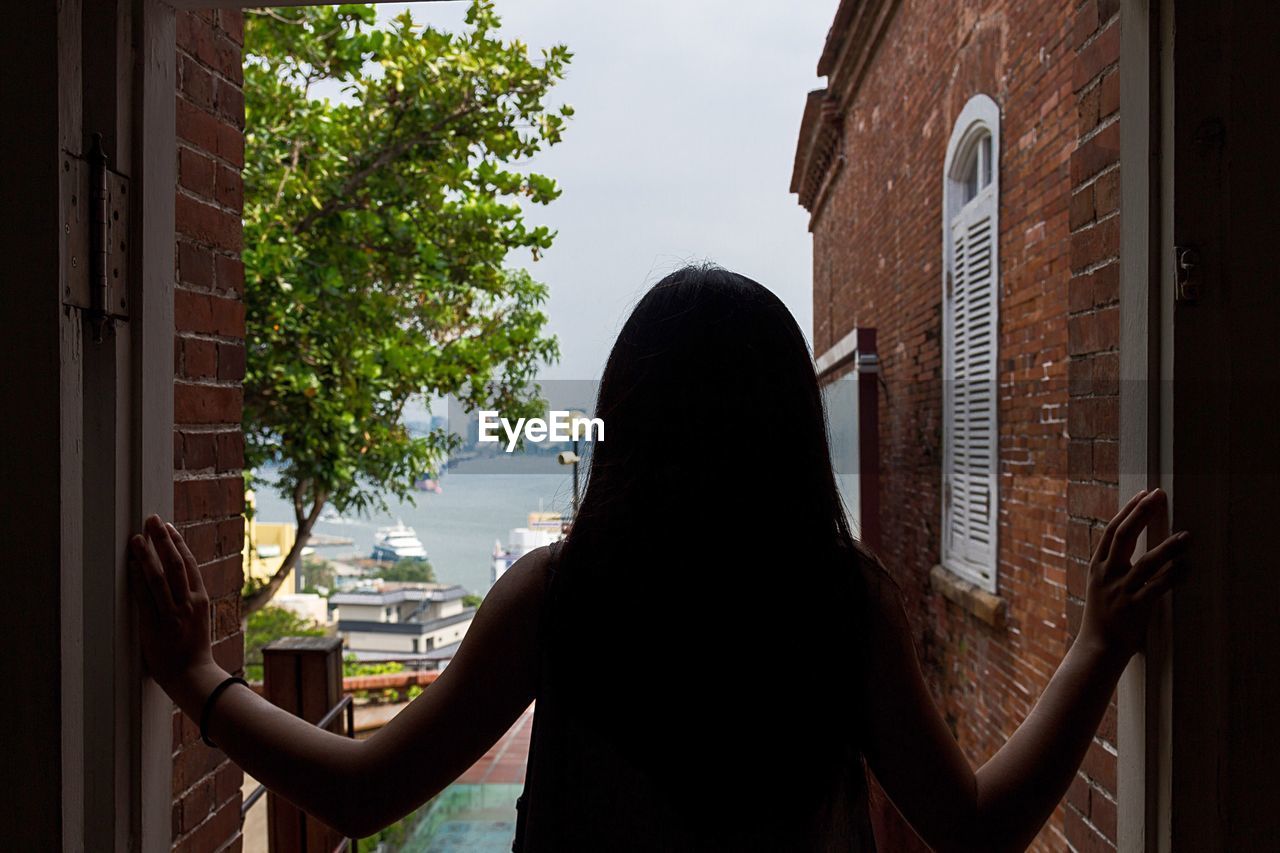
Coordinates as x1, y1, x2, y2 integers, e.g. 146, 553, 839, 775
262, 637, 343, 853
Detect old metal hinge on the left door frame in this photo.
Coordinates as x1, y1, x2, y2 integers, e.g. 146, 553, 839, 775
61, 133, 129, 341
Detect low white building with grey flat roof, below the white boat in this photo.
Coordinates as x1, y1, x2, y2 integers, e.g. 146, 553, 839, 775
329, 583, 476, 669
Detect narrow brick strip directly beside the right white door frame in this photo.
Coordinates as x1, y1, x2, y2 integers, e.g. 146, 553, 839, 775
1066, 0, 1120, 850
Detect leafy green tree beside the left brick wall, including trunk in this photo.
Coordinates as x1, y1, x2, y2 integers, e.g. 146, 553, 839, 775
243, 0, 572, 613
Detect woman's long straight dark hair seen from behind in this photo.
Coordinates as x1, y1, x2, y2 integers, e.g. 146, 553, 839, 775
550, 266, 873, 824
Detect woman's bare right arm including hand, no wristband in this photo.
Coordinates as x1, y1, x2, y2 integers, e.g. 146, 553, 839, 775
864, 491, 1188, 850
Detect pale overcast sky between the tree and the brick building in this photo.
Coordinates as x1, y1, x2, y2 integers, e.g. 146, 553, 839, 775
360, 0, 837, 379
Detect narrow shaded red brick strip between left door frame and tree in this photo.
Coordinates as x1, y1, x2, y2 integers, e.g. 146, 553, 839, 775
173, 12, 244, 850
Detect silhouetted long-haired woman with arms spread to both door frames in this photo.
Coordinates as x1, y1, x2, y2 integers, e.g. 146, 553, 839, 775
132, 268, 1187, 852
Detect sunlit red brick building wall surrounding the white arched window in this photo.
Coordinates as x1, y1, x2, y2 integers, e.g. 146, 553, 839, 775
813, 0, 1080, 850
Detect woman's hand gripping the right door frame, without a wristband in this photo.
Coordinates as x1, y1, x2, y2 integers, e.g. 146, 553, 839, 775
1079, 489, 1190, 663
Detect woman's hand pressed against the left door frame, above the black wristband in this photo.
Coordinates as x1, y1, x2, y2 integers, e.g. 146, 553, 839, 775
129, 515, 216, 703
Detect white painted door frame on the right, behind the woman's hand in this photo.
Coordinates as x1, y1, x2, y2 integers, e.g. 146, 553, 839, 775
1116, 0, 1176, 853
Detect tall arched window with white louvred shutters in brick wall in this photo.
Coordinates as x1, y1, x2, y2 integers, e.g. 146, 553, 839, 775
942, 95, 1000, 592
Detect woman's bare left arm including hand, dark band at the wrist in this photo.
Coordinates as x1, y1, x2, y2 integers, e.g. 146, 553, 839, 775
131, 516, 547, 838
